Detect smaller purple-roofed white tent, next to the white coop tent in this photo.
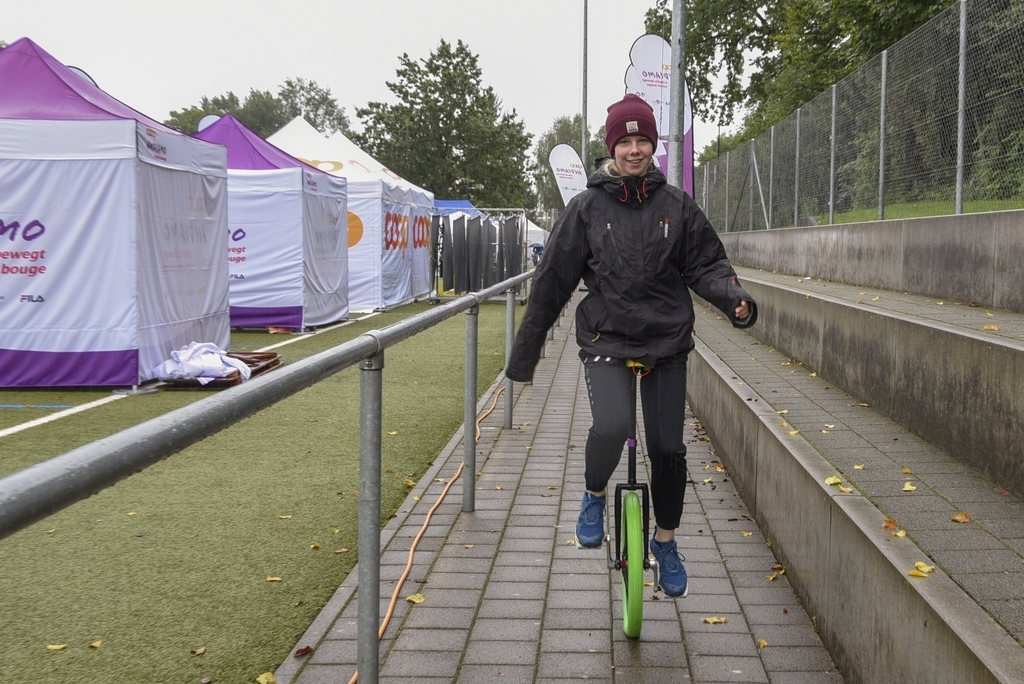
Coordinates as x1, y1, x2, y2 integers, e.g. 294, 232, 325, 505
195, 115, 348, 328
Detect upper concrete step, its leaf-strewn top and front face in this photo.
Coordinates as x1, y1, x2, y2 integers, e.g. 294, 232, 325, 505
737, 268, 1024, 496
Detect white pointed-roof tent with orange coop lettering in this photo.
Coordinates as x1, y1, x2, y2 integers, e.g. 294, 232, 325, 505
267, 117, 434, 312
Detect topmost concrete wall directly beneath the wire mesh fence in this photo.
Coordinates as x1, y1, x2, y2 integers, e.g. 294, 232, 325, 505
720, 210, 1024, 312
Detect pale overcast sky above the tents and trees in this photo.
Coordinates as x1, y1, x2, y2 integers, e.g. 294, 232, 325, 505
0, 0, 718, 152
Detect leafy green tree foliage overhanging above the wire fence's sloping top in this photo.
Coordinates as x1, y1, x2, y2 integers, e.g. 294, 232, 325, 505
645, 0, 955, 140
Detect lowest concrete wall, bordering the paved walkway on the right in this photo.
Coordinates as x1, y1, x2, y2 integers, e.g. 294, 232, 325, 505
687, 341, 1024, 684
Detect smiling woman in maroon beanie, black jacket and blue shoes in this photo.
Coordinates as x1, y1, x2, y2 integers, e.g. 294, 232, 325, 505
505, 94, 757, 637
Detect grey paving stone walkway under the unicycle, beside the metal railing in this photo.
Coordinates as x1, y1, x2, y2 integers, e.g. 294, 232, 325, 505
276, 295, 843, 684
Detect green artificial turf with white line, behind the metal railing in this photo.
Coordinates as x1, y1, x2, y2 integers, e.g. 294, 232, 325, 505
0, 303, 521, 684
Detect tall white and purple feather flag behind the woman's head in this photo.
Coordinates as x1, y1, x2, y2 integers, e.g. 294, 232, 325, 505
624, 34, 693, 197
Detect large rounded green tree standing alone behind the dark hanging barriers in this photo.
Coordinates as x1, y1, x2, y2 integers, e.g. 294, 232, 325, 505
354, 40, 536, 207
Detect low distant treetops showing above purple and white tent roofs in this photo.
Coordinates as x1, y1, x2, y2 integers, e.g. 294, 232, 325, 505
164, 79, 349, 138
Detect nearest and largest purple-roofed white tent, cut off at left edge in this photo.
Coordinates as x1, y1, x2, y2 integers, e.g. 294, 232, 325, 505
0, 38, 230, 387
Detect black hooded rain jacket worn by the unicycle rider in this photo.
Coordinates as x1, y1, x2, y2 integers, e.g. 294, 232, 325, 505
505, 163, 757, 382
